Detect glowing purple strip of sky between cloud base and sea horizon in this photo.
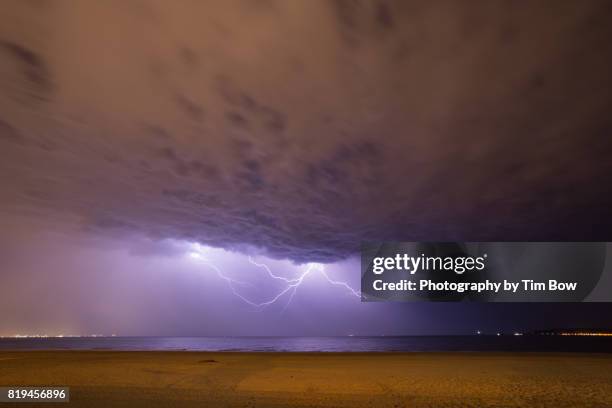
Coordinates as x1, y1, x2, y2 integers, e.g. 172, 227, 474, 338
0, 218, 610, 336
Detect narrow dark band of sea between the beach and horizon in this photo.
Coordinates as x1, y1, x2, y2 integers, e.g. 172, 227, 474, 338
0, 335, 612, 353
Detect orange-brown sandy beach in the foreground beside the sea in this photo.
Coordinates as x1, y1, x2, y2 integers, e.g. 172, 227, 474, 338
0, 351, 612, 408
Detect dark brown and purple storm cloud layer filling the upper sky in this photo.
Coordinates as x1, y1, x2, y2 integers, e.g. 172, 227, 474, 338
0, 0, 612, 262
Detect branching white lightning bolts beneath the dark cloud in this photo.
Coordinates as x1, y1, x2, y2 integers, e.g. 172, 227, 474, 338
189, 244, 361, 312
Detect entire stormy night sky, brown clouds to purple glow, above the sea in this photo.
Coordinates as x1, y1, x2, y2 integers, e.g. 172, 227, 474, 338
0, 0, 612, 335
